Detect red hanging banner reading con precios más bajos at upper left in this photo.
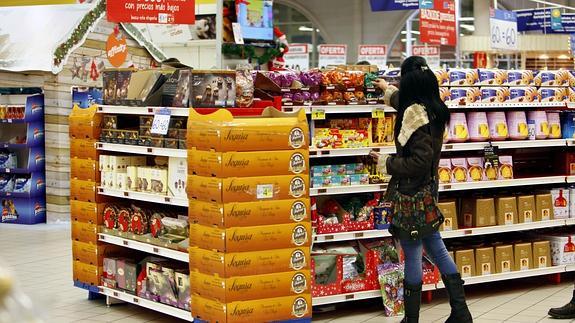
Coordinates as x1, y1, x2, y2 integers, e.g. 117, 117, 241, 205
106, 0, 196, 25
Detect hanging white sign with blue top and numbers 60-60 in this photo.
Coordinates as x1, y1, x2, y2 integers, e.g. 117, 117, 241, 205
489, 9, 519, 50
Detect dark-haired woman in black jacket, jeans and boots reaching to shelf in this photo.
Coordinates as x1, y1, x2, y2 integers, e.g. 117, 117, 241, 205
371, 56, 473, 323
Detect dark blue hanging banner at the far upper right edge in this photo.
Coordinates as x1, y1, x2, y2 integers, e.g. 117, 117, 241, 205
515, 9, 575, 34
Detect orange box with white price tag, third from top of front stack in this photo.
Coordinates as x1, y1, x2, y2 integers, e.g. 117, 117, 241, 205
188, 174, 309, 203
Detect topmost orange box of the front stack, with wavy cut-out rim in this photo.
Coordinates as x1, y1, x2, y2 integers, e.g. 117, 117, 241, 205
187, 108, 309, 151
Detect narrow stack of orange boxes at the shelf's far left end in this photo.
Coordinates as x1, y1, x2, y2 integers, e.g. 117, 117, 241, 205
69, 106, 111, 286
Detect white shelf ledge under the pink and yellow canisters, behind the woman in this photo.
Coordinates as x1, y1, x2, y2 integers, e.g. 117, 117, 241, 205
309, 139, 575, 158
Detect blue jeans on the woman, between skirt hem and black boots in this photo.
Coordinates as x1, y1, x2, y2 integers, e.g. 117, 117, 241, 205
400, 232, 457, 286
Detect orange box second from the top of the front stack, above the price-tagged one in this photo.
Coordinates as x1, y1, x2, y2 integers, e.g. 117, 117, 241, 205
188, 149, 309, 177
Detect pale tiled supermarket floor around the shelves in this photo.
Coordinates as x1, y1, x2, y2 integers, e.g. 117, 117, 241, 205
0, 225, 575, 323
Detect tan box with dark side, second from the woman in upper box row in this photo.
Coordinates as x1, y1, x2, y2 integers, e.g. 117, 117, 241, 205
459, 198, 497, 228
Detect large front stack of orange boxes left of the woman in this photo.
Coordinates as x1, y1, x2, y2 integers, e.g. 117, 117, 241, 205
187, 108, 312, 323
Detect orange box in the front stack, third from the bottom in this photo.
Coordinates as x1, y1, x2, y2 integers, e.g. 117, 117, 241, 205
189, 247, 310, 278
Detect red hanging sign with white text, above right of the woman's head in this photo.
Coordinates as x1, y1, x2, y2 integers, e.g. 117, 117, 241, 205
419, 0, 457, 46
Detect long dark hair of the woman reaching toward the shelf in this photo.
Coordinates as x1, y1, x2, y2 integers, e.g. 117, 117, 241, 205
395, 56, 449, 136
